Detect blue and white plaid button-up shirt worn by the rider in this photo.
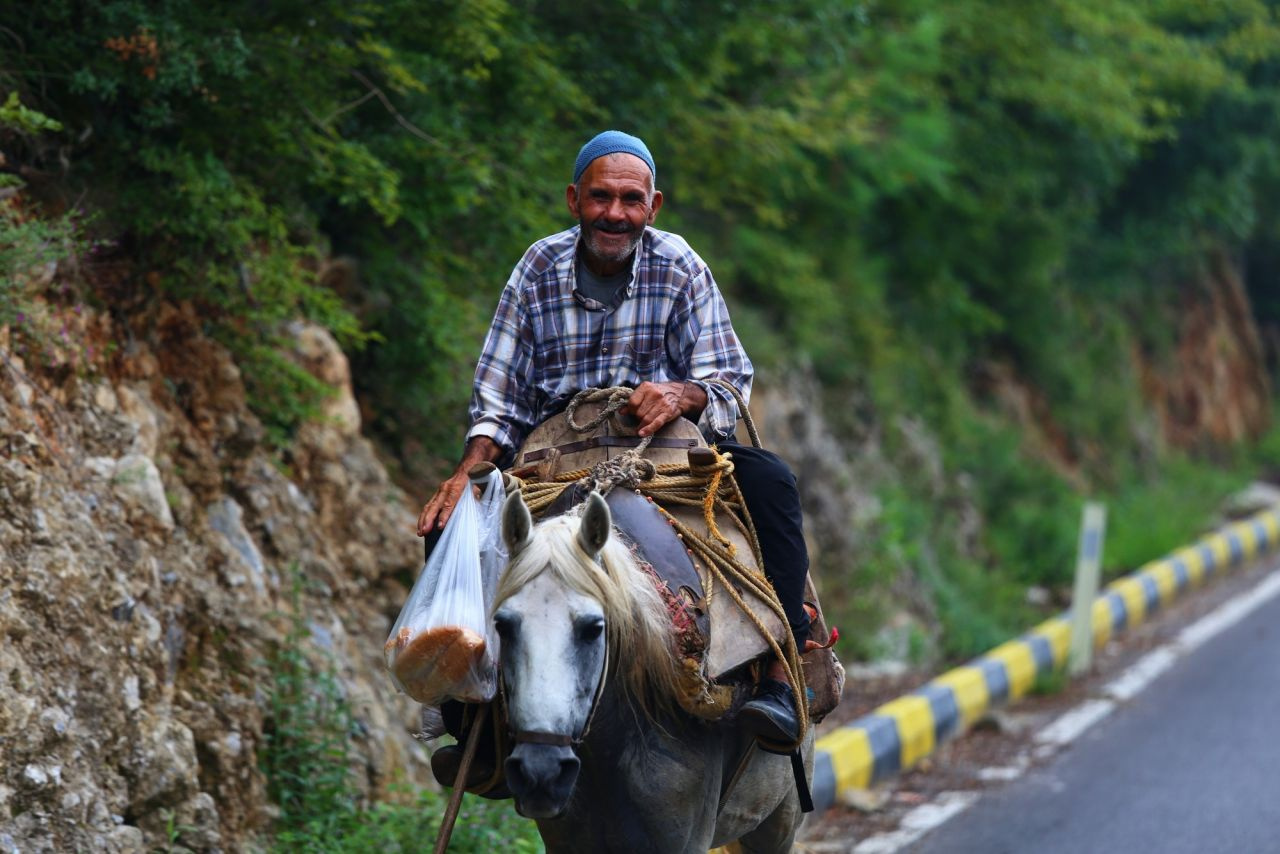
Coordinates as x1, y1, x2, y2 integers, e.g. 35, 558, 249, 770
467, 225, 753, 451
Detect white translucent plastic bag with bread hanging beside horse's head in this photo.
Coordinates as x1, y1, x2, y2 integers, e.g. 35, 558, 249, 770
383, 470, 507, 705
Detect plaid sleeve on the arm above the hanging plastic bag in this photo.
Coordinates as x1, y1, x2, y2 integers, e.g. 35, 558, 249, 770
467, 270, 535, 451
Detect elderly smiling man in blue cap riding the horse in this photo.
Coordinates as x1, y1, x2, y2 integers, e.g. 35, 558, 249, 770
417, 131, 809, 743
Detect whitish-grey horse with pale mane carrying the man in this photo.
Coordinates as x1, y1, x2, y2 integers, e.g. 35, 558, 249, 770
494, 493, 813, 854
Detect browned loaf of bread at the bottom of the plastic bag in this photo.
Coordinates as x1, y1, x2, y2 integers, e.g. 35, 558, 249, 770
385, 626, 485, 704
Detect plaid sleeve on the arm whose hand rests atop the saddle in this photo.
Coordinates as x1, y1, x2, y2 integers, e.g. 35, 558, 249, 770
668, 266, 754, 440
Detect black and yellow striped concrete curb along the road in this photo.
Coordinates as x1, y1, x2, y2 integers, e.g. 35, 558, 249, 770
813, 507, 1280, 812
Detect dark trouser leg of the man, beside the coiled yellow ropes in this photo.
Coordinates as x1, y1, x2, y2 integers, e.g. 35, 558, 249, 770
717, 439, 809, 652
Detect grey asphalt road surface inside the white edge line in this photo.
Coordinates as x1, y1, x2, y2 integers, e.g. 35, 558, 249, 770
908, 571, 1280, 854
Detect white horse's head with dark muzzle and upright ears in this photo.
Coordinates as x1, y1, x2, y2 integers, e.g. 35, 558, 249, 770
494, 492, 612, 818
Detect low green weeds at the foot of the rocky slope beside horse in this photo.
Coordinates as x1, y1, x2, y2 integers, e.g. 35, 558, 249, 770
257, 567, 543, 854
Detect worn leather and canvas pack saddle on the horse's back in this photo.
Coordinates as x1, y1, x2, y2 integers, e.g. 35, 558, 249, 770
513, 403, 844, 722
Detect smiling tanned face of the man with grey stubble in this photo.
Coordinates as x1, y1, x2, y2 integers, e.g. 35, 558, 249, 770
566, 154, 662, 275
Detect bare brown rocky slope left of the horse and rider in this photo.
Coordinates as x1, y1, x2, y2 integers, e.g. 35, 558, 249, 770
0, 305, 422, 854
